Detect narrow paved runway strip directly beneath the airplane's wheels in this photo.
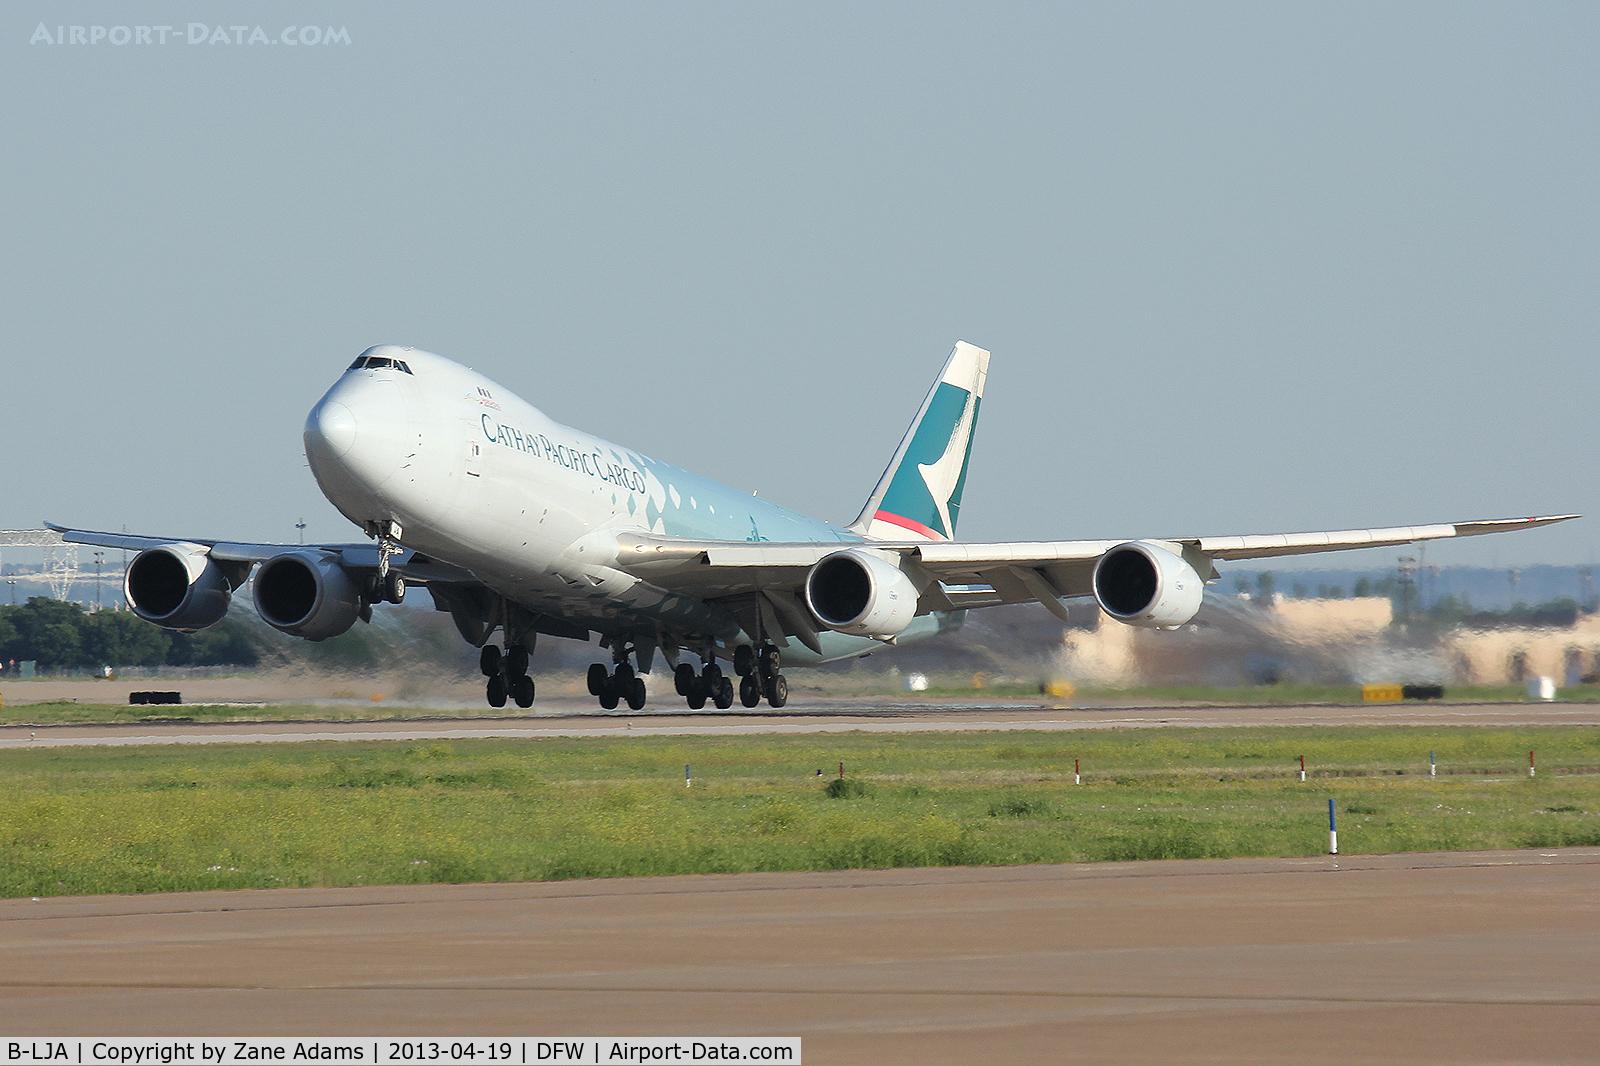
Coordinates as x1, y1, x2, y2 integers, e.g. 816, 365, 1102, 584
0, 699, 1600, 747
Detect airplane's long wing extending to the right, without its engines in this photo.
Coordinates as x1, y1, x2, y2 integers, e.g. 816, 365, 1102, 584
618, 514, 1579, 627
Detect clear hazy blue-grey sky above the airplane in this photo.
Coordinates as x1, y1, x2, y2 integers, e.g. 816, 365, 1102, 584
0, 0, 1600, 567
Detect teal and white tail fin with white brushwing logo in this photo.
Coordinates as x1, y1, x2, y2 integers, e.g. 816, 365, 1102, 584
850, 341, 989, 541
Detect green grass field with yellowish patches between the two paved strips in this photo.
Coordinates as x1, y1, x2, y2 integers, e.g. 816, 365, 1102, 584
0, 727, 1600, 896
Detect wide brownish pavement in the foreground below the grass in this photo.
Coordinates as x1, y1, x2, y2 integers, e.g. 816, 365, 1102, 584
0, 848, 1600, 1064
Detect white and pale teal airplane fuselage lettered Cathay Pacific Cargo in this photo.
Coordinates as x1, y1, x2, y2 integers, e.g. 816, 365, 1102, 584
306, 346, 938, 661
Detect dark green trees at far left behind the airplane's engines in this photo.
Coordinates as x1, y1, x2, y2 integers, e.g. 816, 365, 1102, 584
0, 595, 261, 672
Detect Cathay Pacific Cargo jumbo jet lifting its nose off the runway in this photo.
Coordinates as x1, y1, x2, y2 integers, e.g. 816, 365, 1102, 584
51, 341, 1579, 711
